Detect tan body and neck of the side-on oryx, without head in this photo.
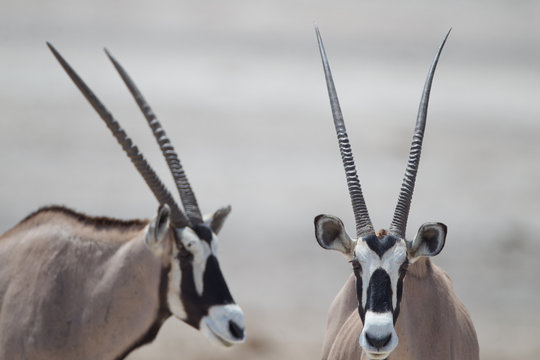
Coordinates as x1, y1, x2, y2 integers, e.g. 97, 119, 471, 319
0, 211, 167, 360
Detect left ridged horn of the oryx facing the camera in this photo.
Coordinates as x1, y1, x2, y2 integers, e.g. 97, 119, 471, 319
315, 27, 375, 237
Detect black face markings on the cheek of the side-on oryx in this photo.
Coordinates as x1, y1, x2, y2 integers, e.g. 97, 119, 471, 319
179, 255, 234, 329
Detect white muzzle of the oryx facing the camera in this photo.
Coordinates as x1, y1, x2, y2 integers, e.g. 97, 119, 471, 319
358, 311, 398, 360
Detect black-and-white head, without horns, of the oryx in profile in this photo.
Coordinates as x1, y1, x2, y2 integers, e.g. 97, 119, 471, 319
144, 207, 245, 346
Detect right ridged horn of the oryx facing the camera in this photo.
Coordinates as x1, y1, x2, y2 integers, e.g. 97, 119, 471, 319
389, 29, 452, 238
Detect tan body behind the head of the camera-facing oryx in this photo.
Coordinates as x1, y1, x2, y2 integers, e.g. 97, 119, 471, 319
322, 258, 479, 360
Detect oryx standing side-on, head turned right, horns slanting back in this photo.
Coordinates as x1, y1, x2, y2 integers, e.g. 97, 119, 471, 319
0, 44, 245, 360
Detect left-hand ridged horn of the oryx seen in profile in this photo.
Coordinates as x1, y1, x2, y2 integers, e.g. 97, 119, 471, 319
47, 42, 189, 227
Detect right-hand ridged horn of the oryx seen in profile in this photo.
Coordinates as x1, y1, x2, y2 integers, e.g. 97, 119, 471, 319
105, 49, 203, 225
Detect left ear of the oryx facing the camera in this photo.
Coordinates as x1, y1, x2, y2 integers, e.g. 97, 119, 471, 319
315, 214, 356, 259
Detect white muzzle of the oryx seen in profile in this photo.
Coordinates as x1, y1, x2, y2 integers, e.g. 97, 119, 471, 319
199, 304, 246, 347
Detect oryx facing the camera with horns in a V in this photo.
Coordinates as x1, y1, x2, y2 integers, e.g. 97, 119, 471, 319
315, 29, 479, 360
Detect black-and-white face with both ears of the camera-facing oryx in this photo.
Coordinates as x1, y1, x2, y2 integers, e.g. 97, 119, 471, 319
315, 215, 446, 359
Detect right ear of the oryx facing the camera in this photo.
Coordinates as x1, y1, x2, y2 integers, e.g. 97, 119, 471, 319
407, 223, 447, 262
